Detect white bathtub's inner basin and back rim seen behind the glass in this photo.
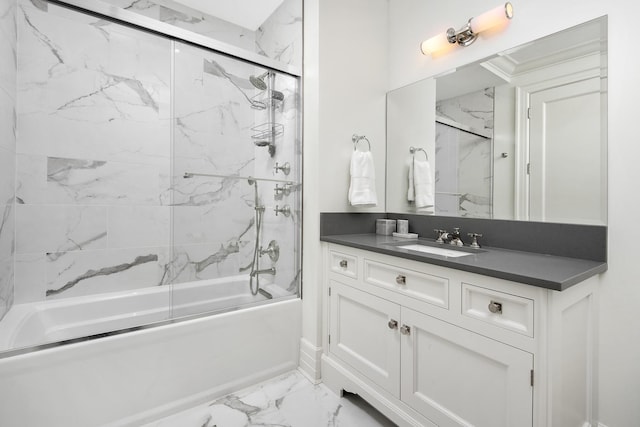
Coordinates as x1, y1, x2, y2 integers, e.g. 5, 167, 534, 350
0, 276, 291, 351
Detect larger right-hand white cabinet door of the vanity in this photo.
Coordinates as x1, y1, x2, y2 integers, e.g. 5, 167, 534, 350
401, 308, 533, 427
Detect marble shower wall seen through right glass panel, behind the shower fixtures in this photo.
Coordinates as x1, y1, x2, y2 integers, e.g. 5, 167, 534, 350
171, 44, 300, 293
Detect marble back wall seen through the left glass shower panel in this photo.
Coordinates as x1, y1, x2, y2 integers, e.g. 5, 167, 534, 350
15, 0, 171, 303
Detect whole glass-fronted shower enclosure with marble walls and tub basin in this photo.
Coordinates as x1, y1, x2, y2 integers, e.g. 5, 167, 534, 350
0, 0, 302, 351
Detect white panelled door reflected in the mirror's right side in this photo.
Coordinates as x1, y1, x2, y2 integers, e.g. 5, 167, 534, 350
529, 77, 606, 224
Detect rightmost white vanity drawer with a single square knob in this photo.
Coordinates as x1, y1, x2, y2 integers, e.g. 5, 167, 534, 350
462, 283, 533, 337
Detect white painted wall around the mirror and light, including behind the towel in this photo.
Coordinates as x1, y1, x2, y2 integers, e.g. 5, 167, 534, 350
303, 0, 640, 427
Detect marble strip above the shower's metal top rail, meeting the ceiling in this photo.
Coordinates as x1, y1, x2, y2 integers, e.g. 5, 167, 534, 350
103, 0, 302, 68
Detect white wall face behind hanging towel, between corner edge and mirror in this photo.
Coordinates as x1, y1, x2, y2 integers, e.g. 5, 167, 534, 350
317, 0, 388, 212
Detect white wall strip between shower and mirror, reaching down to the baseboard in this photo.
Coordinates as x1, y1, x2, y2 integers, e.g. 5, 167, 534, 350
300, 0, 388, 379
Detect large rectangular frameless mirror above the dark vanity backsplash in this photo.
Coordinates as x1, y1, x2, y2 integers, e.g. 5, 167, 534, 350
387, 17, 607, 225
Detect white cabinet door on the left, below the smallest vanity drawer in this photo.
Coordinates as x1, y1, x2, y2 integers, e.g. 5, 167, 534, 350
329, 281, 400, 397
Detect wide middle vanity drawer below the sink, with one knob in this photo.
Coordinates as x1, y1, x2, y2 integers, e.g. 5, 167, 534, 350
364, 259, 449, 309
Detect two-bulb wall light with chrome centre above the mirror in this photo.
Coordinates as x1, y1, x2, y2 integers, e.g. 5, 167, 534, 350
420, 2, 513, 55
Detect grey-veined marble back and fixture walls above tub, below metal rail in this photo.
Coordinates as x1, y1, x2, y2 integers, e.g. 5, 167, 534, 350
12, 0, 301, 303
